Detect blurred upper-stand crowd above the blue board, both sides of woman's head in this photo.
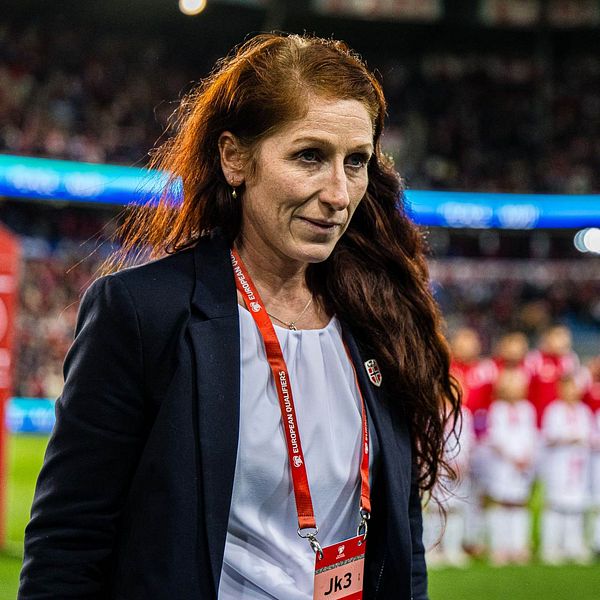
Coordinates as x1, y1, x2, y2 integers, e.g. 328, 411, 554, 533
0, 24, 600, 193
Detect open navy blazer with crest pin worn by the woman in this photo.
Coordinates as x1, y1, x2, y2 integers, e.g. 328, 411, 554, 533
18, 235, 427, 600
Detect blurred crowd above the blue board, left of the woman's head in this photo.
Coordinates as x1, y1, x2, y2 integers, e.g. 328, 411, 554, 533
0, 24, 192, 164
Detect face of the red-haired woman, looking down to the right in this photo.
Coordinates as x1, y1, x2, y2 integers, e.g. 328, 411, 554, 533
234, 96, 373, 264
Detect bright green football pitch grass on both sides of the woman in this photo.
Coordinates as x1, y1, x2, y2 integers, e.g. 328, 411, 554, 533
0, 435, 600, 600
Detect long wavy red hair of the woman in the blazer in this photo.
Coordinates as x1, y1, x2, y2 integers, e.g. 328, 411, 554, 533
110, 34, 460, 490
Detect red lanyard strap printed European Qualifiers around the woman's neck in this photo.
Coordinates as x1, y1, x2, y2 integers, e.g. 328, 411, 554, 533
231, 249, 371, 538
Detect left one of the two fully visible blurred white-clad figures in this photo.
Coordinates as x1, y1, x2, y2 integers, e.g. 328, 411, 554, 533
485, 368, 539, 565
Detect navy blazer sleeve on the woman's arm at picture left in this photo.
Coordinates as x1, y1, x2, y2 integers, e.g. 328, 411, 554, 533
18, 274, 145, 600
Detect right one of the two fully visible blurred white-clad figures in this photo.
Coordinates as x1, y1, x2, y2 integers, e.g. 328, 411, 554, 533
542, 375, 593, 564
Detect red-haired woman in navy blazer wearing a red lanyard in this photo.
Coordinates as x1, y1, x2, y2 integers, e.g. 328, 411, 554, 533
19, 34, 457, 600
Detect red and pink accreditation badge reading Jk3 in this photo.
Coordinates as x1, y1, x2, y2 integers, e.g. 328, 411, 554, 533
313, 535, 367, 600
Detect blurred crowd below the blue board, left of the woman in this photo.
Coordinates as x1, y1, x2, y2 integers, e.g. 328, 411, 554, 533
0, 202, 117, 398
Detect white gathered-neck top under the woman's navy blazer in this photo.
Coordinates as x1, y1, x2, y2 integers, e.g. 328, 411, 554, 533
219, 307, 376, 600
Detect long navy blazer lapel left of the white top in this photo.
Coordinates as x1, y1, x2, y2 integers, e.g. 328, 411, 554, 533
189, 237, 240, 593
